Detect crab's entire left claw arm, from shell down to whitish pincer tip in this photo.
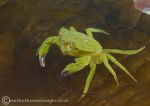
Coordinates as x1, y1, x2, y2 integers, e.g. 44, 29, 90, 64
37, 37, 58, 67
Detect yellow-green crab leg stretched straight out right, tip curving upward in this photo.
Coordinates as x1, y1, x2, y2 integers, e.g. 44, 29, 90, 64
103, 46, 145, 55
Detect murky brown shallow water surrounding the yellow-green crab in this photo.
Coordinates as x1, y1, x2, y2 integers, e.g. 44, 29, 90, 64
0, 0, 150, 106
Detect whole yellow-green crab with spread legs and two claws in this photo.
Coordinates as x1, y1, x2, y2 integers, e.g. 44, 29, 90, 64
37, 27, 145, 98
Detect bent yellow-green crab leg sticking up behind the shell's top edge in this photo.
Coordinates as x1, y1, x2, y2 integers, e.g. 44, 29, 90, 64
85, 28, 109, 38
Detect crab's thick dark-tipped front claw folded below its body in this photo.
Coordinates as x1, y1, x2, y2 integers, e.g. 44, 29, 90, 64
61, 56, 91, 76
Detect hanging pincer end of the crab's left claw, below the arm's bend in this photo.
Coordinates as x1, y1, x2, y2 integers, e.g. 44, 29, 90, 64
37, 44, 49, 67
